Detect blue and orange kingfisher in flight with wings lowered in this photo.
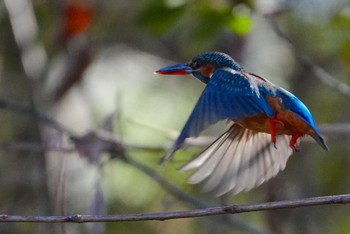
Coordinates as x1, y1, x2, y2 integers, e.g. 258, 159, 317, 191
155, 52, 328, 196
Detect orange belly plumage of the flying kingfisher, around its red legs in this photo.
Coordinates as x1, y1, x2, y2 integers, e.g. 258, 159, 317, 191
238, 96, 315, 135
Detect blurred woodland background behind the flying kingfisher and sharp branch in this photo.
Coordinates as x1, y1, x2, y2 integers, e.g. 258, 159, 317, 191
0, 0, 350, 234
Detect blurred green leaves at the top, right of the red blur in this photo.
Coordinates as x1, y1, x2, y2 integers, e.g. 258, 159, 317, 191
137, 0, 252, 36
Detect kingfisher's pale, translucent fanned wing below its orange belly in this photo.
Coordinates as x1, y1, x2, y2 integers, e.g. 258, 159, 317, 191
180, 124, 293, 196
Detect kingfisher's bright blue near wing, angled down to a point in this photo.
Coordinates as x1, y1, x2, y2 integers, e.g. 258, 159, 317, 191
162, 68, 273, 161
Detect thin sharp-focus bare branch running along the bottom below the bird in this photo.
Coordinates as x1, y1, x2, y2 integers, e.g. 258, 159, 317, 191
0, 194, 350, 223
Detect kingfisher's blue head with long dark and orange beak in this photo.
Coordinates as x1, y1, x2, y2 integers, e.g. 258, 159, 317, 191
155, 52, 241, 83
